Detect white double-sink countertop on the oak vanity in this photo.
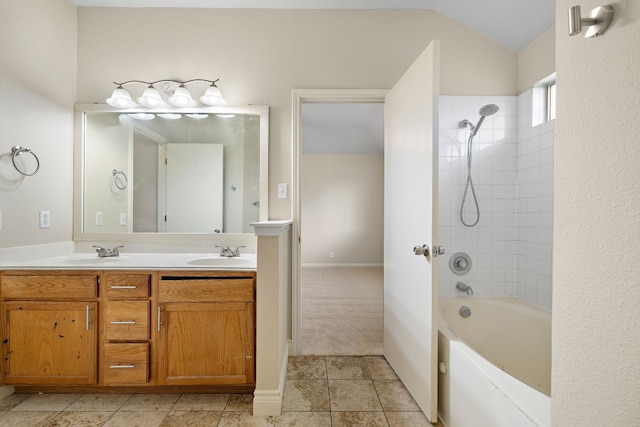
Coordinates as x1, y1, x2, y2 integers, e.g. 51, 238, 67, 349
0, 253, 257, 271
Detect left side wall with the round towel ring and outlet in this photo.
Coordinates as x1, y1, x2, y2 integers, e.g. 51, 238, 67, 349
0, 0, 77, 248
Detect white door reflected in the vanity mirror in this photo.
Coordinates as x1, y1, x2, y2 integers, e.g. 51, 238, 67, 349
165, 143, 224, 233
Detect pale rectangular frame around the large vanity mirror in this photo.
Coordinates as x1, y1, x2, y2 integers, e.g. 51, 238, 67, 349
73, 104, 269, 244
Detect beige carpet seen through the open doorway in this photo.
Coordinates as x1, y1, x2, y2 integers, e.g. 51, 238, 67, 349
300, 267, 384, 356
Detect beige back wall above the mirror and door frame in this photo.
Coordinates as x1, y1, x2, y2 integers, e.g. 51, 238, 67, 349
78, 8, 517, 224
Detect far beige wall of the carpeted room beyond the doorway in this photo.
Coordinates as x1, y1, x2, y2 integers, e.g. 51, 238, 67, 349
301, 154, 384, 266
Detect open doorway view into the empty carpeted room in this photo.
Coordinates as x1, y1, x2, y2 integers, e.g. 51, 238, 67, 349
300, 103, 384, 355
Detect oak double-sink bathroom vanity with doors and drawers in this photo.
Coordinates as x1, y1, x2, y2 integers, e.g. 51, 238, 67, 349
0, 254, 256, 392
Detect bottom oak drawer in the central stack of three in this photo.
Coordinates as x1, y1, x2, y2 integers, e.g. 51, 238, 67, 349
103, 344, 149, 385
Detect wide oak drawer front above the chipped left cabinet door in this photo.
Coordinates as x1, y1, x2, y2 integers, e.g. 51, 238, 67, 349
2, 274, 98, 300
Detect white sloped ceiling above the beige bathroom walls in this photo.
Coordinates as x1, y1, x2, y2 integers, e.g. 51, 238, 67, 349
71, 0, 556, 52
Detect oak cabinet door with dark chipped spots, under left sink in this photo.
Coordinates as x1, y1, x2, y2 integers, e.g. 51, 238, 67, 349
2, 301, 97, 384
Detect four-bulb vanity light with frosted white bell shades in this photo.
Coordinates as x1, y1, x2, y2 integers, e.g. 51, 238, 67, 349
107, 79, 227, 108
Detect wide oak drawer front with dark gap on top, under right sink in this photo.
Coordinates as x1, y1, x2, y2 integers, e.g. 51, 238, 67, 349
159, 277, 254, 302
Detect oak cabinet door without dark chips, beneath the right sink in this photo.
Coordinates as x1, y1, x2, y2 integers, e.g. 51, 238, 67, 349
160, 302, 255, 385
